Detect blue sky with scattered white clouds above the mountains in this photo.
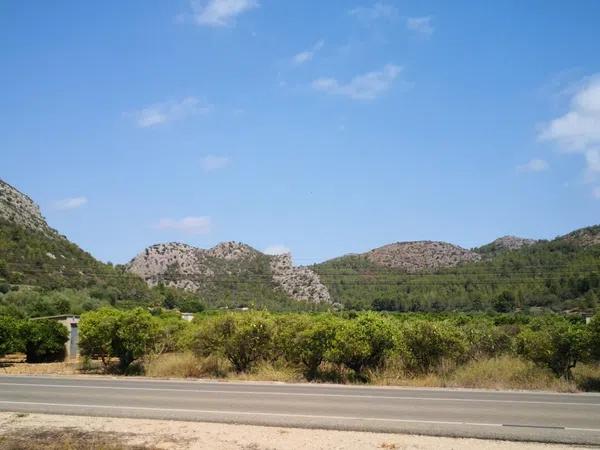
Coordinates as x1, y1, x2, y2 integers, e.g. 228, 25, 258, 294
0, 0, 600, 264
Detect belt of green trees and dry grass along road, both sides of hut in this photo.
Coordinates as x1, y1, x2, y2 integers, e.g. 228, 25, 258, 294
0, 308, 600, 391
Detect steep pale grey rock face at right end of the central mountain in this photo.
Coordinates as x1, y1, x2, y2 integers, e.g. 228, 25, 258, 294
271, 253, 331, 303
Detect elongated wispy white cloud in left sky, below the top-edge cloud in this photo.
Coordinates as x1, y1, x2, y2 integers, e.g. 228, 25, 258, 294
125, 97, 210, 128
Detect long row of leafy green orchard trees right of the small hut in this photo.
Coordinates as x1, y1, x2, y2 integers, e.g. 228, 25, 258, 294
75, 309, 600, 381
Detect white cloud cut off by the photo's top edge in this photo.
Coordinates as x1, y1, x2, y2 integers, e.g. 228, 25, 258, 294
190, 0, 259, 27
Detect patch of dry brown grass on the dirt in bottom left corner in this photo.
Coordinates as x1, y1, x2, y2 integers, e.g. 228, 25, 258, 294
0, 429, 152, 450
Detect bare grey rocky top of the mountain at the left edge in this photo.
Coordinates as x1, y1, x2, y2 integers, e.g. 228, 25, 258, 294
0, 180, 58, 237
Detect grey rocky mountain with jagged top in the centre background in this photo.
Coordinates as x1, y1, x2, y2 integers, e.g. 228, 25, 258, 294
126, 242, 330, 306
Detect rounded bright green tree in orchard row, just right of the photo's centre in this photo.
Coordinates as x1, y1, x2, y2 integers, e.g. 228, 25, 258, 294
327, 312, 394, 381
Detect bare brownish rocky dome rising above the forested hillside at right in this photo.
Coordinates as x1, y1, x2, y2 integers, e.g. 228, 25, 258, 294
364, 241, 481, 273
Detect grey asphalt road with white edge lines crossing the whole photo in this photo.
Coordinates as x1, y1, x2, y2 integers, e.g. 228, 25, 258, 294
0, 376, 600, 445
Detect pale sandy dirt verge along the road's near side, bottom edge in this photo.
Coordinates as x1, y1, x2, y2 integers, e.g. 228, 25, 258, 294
0, 413, 583, 450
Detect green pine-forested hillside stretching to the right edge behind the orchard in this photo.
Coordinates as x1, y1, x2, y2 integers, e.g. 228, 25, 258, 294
313, 226, 600, 312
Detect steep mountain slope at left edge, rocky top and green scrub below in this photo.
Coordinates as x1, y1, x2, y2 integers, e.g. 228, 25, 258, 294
0, 180, 149, 303
